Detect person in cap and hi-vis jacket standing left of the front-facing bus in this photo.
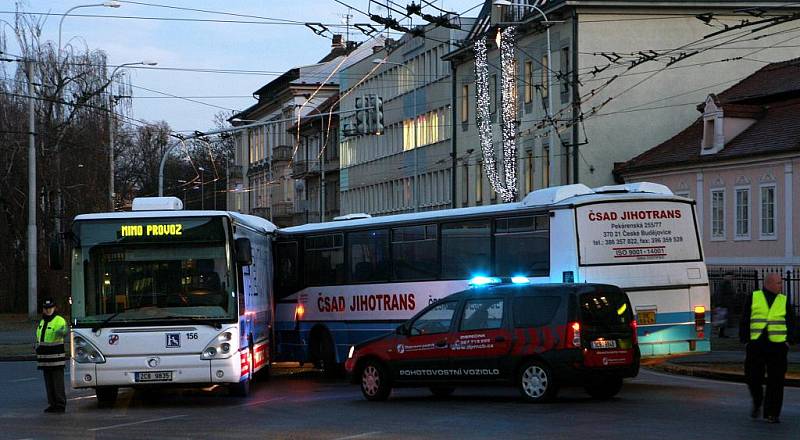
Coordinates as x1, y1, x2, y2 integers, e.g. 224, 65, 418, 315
36, 298, 68, 413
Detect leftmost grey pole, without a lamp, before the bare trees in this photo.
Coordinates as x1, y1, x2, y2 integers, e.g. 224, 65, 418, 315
25, 59, 38, 318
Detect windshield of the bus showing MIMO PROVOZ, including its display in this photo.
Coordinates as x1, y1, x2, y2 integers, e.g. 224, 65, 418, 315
73, 217, 238, 325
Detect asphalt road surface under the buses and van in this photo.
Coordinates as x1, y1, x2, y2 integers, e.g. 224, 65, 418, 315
0, 362, 800, 440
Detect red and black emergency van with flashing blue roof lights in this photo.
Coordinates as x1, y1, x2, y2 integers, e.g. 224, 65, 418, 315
345, 277, 640, 402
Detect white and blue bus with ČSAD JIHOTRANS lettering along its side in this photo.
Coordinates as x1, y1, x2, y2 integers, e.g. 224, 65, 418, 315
275, 183, 710, 366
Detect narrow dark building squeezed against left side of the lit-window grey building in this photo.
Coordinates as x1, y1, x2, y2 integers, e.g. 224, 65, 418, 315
289, 95, 339, 224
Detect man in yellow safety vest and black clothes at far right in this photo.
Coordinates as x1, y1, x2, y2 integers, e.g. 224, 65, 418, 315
739, 273, 795, 423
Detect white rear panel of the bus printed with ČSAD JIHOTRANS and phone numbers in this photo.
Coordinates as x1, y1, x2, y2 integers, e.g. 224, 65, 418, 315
575, 201, 700, 265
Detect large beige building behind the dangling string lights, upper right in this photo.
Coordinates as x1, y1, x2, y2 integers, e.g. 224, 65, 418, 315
445, 0, 800, 206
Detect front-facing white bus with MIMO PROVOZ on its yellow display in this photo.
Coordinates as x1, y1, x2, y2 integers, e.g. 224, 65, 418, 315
70, 197, 275, 405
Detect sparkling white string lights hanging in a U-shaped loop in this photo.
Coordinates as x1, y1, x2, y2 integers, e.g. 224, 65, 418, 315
474, 27, 517, 202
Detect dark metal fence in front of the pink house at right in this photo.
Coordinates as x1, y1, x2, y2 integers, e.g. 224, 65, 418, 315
708, 266, 800, 321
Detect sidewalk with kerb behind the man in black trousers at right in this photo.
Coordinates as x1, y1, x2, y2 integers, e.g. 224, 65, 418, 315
652, 338, 800, 386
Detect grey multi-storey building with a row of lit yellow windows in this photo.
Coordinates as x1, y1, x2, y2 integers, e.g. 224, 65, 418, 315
340, 19, 471, 215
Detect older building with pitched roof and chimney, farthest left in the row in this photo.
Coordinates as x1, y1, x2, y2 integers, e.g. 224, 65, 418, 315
228, 35, 382, 226
